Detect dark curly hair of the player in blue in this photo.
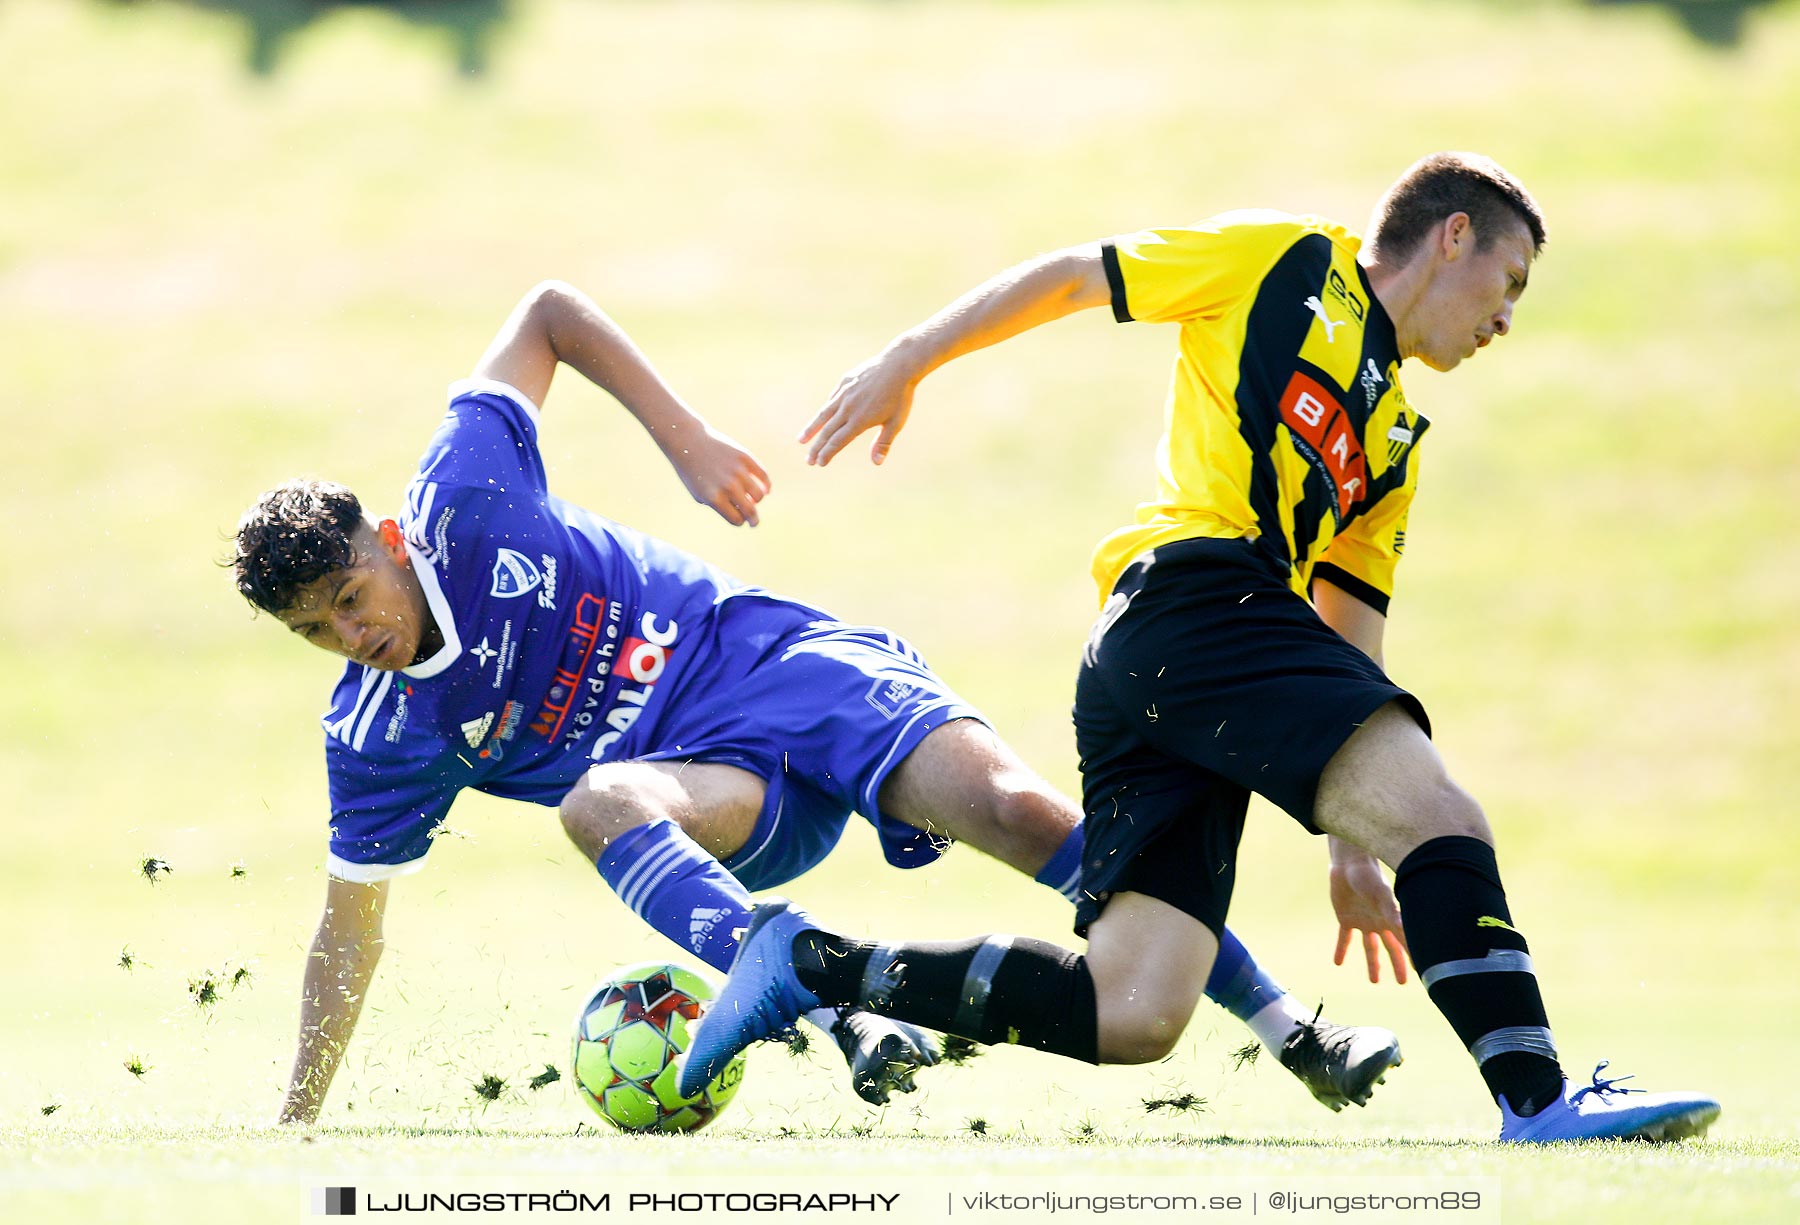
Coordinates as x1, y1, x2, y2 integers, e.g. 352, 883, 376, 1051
232, 480, 362, 613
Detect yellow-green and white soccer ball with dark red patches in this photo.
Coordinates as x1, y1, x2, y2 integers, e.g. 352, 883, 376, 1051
572, 961, 743, 1131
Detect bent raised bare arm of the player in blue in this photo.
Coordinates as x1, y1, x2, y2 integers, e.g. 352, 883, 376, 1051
475, 281, 769, 527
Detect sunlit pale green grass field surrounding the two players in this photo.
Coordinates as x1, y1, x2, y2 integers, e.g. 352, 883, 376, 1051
0, 0, 1800, 1225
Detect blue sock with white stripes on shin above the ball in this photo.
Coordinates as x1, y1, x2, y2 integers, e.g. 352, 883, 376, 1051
594, 818, 751, 970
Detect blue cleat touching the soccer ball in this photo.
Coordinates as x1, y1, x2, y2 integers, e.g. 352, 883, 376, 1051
679, 898, 819, 1097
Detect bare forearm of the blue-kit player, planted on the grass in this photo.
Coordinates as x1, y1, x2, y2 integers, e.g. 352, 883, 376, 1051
279, 878, 387, 1124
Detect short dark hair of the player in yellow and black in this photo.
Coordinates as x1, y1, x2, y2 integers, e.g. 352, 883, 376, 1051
1373, 153, 1544, 263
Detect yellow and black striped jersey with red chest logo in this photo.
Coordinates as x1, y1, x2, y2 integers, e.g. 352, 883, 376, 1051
1093, 210, 1427, 612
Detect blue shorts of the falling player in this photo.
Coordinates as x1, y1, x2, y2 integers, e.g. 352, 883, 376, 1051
632, 621, 985, 892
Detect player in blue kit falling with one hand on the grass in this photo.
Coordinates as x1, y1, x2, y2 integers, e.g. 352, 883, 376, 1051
234, 282, 1404, 1122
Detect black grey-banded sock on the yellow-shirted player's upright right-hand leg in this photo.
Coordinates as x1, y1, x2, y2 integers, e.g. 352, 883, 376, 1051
1393, 836, 1562, 1115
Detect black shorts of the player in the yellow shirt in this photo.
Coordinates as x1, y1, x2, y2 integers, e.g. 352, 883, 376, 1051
1075, 540, 1431, 935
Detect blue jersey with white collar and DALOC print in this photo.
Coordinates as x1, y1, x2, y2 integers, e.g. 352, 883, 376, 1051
324, 381, 824, 881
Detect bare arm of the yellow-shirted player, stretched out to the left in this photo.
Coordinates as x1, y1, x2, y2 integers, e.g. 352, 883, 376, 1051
799, 243, 1112, 466
